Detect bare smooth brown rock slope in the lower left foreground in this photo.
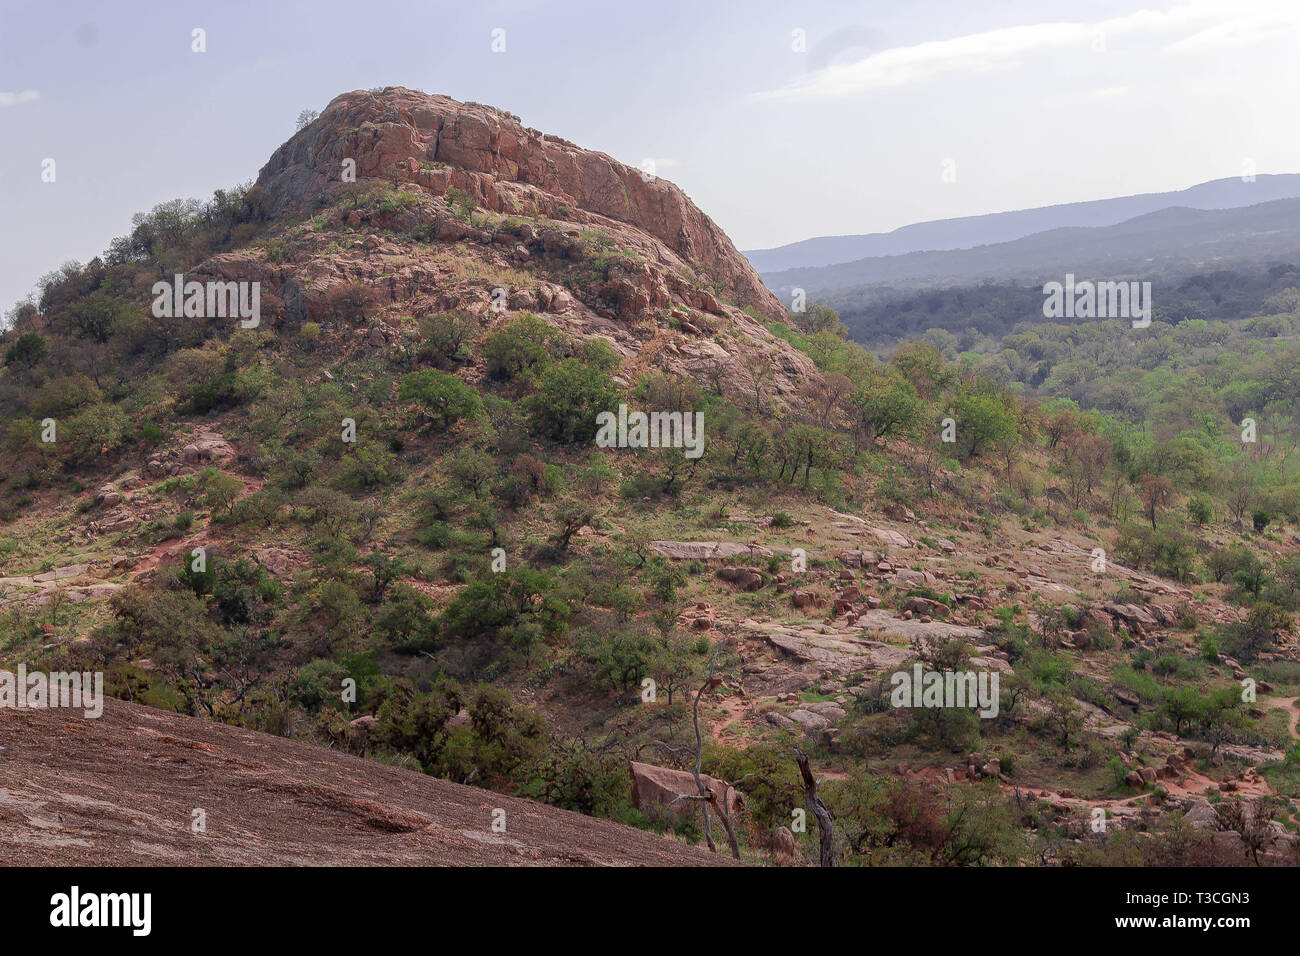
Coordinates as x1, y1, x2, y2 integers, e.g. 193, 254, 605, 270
0, 701, 723, 866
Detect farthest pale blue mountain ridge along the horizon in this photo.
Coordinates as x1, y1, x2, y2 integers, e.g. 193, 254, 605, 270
744, 173, 1300, 276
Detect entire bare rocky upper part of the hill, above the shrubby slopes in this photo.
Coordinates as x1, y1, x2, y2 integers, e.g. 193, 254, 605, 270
192, 87, 819, 398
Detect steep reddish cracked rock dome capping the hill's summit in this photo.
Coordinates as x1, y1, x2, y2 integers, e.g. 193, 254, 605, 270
257, 87, 785, 317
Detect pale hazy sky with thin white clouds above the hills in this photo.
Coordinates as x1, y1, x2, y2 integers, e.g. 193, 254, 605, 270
0, 0, 1300, 311
